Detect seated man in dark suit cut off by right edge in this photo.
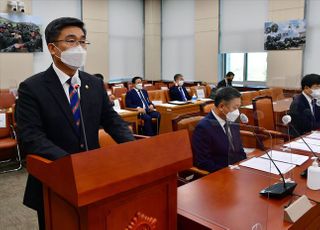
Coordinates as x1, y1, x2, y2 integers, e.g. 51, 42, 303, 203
289, 74, 320, 137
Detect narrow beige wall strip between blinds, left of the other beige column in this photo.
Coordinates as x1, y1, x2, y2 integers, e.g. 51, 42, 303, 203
144, 0, 161, 80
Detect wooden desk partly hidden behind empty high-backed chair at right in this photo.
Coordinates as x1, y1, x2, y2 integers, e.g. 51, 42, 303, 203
240, 98, 293, 125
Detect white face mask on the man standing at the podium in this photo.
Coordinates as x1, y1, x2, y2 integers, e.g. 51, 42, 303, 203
56, 45, 87, 70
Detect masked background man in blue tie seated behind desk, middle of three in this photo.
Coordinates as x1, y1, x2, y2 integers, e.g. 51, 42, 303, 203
169, 74, 191, 101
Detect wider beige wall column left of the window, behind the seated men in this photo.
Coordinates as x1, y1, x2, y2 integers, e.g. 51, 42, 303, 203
194, 0, 219, 82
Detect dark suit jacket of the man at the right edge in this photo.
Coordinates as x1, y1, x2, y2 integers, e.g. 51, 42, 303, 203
289, 94, 320, 137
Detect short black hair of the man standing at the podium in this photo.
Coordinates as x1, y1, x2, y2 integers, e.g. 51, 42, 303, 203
45, 17, 87, 44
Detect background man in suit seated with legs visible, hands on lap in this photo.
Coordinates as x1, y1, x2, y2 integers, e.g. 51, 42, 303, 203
126, 77, 160, 136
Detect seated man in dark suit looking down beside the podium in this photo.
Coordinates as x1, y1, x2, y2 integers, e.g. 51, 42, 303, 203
192, 87, 246, 172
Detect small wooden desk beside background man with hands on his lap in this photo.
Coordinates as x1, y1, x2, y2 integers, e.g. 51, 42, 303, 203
157, 101, 205, 133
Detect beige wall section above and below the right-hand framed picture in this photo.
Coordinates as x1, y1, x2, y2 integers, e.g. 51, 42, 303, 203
267, 0, 305, 88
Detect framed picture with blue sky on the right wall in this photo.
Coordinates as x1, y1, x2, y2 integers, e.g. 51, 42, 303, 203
264, 19, 306, 50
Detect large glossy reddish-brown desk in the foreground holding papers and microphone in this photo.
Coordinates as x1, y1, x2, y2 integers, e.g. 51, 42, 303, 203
178, 146, 320, 230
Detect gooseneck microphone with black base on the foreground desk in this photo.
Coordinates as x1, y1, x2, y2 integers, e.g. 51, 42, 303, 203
240, 113, 297, 199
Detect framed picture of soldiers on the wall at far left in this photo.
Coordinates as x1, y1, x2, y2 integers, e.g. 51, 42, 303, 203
0, 13, 43, 53
